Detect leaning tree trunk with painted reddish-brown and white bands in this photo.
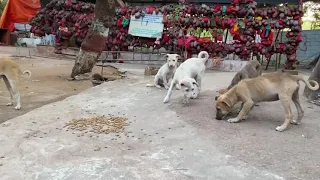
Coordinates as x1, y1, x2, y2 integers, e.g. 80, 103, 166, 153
71, 0, 123, 79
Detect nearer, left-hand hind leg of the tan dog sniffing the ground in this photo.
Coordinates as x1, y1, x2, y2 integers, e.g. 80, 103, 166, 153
276, 93, 292, 132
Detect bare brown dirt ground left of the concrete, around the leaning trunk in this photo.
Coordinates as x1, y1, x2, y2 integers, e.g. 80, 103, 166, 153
0, 58, 120, 123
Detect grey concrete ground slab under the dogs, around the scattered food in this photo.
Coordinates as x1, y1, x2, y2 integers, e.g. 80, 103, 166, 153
0, 65, 320, 180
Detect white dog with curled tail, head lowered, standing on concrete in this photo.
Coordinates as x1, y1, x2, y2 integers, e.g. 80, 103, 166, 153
163, 51, 209, 104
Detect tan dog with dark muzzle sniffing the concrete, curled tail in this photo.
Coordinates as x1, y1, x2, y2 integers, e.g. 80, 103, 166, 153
216, 72, 319, 131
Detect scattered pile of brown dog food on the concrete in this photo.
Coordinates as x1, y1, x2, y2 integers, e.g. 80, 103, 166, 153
65, 116, 129, 134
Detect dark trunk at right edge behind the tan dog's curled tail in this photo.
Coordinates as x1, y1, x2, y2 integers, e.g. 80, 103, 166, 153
304, 57, 320, 101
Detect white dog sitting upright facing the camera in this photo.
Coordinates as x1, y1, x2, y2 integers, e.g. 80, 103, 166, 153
147, 54, 180, 89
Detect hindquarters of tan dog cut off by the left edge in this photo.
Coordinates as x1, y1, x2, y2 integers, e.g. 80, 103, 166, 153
0, 58, 31, 110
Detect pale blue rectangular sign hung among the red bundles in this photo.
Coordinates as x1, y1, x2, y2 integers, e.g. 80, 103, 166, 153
129, 14, 163, 38
